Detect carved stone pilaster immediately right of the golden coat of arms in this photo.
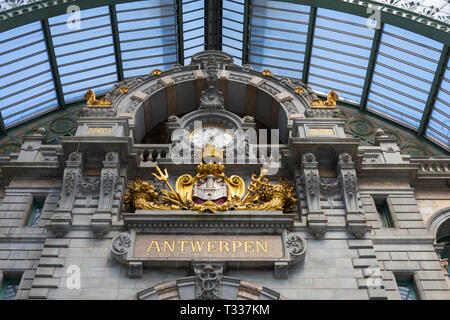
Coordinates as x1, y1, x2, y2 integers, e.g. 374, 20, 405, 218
302, 153, 328, 237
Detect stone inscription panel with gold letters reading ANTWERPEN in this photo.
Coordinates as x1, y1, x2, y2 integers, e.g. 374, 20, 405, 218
133, 234, 284, 260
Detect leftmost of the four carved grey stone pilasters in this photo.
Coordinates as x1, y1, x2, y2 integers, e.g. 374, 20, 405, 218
48, 152, 83, 237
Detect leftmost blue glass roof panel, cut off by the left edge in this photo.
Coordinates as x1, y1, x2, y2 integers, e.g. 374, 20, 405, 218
0, 22, 58, 127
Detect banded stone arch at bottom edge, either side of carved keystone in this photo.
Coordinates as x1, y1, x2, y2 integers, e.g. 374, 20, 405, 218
135, 276, 286, 300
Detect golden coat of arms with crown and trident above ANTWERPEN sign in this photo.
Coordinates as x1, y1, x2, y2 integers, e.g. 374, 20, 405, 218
124, 163, 297, 213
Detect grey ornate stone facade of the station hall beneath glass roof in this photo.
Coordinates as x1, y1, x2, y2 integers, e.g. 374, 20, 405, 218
0, 51, 450, 300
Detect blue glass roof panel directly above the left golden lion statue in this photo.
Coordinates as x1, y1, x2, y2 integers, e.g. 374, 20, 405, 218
49, 7, 117, 102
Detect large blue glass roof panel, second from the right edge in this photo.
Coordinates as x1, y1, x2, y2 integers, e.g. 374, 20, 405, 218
367, 24, 443, 131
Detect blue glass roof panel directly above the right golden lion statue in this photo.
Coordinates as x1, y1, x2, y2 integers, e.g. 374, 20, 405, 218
308, 8, 375, 103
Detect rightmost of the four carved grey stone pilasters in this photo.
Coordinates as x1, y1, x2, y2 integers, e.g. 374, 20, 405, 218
337, 152, 370, 237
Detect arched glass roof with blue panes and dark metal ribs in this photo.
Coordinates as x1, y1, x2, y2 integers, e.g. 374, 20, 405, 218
0, 0, 450, 151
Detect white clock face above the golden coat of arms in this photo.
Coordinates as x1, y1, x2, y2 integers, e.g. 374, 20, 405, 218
191, 125, 233, 148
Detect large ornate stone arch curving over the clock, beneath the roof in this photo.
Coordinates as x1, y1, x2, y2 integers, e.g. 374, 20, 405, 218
99, 51, 317, 142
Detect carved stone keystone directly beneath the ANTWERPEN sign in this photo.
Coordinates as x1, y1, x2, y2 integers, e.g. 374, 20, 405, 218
194, 263, 223, 300
